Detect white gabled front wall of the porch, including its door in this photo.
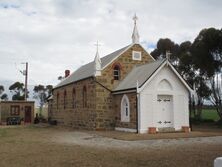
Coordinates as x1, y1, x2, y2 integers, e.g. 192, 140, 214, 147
139, 64, 189, 133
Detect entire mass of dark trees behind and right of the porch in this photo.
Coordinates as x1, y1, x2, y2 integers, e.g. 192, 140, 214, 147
151, 28, 222, 120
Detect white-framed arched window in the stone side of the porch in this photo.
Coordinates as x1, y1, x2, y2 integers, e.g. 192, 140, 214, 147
121, 95, 130, 122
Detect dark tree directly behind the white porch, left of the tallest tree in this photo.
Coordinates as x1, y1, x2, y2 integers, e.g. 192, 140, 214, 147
151, 38, 210, 120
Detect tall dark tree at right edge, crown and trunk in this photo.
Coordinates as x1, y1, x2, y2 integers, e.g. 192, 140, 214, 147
191, 28, 222, 121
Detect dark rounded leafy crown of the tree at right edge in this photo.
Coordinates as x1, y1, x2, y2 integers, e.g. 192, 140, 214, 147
191, 28, 222, 77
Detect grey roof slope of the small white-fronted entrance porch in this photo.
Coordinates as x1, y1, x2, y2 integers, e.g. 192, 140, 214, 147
114, 59, 166, 91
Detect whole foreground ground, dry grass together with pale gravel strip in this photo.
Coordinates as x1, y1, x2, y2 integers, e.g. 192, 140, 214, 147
0, 126, 222, 167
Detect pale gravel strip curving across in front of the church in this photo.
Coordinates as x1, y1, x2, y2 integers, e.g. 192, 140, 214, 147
52, 132, 222, 149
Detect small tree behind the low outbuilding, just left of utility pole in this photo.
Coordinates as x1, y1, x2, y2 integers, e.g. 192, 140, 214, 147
9, 82, 29, 100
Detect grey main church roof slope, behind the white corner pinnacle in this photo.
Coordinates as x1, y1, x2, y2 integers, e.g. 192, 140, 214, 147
54, 45, 132, 88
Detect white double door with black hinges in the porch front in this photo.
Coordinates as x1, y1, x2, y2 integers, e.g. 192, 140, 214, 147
157, 95, 173, 127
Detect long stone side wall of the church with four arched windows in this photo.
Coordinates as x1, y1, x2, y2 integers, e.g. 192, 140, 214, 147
51, 78, 96, 129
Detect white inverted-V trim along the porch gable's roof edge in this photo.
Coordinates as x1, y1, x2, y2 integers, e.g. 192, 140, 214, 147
138, 60, 193, 93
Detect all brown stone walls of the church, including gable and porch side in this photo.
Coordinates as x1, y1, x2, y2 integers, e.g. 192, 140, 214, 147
50, 44, 153, 130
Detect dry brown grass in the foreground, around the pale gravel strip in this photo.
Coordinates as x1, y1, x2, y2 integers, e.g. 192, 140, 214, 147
0, 126, 222, 167
